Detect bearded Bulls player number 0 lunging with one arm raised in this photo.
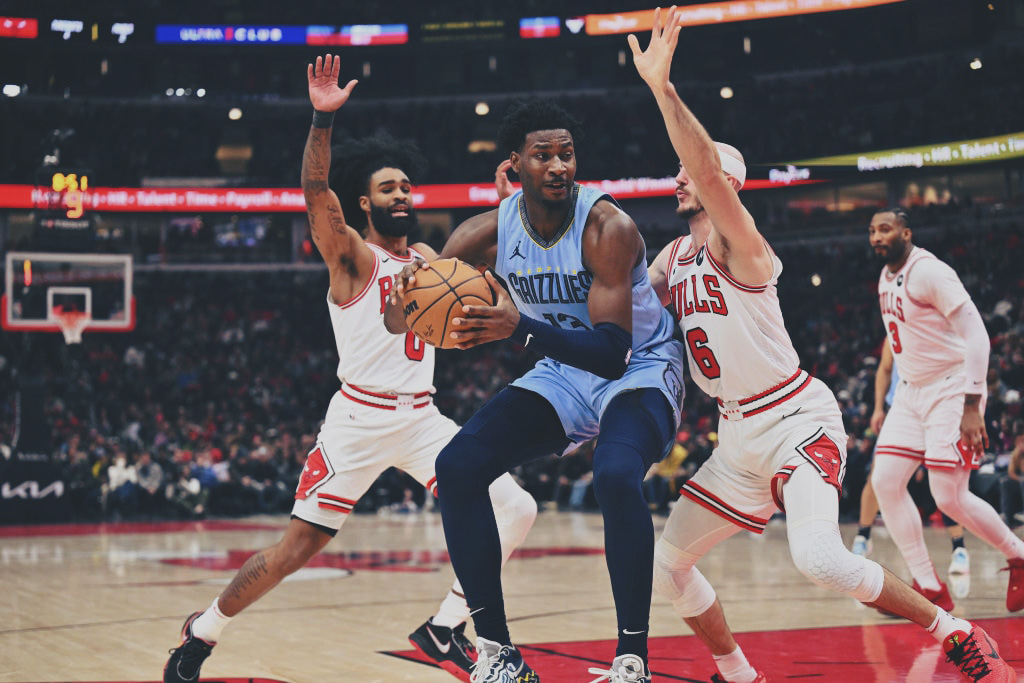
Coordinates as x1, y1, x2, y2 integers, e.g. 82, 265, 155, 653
164, 54, 537, 683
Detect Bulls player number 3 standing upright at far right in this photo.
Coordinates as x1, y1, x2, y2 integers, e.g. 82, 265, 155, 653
868, 208, 1024, 611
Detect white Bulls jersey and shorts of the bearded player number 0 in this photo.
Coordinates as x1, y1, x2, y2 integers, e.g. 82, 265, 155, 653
293, 245, 459, 528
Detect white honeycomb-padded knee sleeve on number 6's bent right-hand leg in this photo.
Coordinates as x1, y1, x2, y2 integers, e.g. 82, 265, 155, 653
790, 522, 882, 602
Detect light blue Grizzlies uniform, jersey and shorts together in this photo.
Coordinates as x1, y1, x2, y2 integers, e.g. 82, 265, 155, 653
495, 185, 683, 449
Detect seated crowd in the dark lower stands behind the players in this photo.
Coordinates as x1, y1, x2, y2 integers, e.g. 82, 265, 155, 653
0, 208, 1024, 525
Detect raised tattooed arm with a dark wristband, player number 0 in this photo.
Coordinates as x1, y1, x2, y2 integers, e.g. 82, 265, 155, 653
302, 54, 374, 303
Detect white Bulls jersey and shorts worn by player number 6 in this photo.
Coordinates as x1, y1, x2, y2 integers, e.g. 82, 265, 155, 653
668, 237, 846, 533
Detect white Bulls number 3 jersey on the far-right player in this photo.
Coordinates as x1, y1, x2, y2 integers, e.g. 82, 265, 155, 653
879, 247, 971, 385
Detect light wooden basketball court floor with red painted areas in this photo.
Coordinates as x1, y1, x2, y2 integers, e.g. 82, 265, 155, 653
0, 511, 1024, 683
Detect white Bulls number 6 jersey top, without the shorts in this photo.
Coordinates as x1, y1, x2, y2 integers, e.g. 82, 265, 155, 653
668, 236, 798, 401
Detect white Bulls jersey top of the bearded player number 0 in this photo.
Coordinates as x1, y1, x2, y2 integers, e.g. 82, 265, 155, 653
328, 244, 434, 394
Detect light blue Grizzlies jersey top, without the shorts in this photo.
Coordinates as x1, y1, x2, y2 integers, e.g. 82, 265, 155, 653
495, 184, 673, 354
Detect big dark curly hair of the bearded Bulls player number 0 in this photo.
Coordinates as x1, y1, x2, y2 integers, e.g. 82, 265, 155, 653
328, 133, 427, 230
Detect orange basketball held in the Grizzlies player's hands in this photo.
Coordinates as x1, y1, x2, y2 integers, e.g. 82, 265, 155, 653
403, 258, 495, 348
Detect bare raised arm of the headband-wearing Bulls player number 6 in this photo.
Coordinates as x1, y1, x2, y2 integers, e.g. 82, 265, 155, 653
627, 7, 773, 283
